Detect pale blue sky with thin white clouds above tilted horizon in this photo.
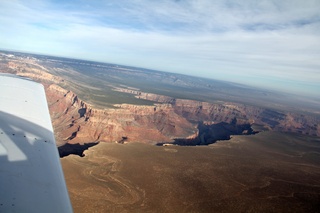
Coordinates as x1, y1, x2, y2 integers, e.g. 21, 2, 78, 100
0, 0, 320, 98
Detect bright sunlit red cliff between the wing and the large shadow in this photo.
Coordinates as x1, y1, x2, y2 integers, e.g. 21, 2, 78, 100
46, 84, 197, 144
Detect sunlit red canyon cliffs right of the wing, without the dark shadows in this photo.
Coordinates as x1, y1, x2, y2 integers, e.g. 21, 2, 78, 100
46, 84, 320, 144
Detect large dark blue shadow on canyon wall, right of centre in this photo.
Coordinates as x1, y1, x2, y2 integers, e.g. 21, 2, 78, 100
157, 118, 259, 146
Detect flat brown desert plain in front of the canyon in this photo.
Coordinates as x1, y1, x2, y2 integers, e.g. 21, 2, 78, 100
61, 131, 320, 212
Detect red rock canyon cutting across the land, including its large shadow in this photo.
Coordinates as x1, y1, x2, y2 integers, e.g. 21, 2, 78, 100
1, 54, 320, 151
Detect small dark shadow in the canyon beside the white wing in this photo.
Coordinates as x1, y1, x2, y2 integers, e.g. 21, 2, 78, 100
58, 142, 99, 158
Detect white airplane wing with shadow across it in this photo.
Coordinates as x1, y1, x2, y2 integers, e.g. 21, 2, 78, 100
0, 74, 72, 212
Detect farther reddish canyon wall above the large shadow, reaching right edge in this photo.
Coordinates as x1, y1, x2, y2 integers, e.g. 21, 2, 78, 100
117, 89, 320, 136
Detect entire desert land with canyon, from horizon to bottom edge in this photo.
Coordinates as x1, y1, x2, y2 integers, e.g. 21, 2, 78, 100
0, 51, 320, 212
